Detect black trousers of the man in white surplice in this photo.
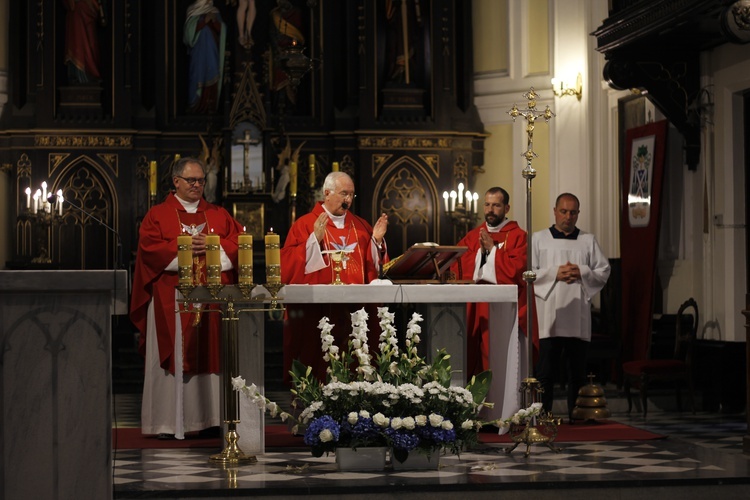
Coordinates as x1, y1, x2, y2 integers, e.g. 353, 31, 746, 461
535, 337, 589, 418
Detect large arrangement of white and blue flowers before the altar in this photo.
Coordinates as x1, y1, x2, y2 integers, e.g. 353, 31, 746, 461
232, 307, 496, 462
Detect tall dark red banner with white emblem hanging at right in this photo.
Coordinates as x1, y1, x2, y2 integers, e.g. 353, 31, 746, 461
620, 121, 667, 361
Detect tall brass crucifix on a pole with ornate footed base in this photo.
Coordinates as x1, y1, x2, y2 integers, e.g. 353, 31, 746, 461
506, 87, 560, 456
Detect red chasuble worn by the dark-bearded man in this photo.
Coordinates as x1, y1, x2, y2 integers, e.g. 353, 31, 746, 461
451, 221, 539, 377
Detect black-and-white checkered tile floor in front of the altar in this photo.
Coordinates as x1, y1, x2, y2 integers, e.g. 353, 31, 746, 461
113, 395, 750, 500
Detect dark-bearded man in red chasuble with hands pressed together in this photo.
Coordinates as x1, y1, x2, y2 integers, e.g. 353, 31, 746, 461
452, 187, 537, 378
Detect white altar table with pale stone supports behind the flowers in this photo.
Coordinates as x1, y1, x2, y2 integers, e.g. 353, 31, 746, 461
237, 284, 528, 454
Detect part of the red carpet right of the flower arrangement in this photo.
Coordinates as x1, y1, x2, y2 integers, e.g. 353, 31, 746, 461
479, 420, 665, 443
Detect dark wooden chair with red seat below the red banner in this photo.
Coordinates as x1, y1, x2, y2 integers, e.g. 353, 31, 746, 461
622, 297, 698, 417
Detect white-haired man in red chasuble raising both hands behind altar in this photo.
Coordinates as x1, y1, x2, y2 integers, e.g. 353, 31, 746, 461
281, 172, 388, 380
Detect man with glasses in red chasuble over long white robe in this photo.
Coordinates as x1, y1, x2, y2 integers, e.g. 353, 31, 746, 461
130, 158, 242, 439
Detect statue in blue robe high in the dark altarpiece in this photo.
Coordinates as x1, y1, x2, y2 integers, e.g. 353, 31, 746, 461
183, 0, 227, 114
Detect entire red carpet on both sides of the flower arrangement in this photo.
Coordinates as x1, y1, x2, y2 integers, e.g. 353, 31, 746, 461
112, 420, 664, 451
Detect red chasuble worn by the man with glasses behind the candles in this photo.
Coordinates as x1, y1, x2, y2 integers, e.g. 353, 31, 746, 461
130, 193, 242, 374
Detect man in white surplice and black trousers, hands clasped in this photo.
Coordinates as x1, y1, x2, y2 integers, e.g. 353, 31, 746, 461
531, 193, 610, 418
